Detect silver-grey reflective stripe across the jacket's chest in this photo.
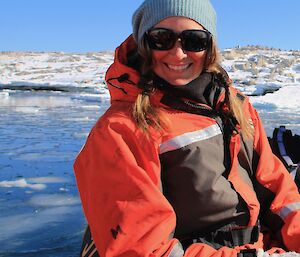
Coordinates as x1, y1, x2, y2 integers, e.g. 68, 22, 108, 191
160, 124, 222, 154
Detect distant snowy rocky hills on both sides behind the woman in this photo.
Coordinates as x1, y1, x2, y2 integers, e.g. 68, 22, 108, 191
0, 46, 300, 95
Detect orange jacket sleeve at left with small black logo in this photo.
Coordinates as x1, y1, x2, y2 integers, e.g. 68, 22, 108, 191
74, 113, 237, 257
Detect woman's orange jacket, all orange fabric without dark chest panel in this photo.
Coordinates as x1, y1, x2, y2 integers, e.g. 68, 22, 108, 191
74, 37, 300, 257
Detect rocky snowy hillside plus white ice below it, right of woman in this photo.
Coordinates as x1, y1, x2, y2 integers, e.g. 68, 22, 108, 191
222, 46, 300, 135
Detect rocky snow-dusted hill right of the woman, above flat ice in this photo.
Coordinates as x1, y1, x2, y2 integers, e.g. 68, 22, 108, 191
222, 46, 300, 95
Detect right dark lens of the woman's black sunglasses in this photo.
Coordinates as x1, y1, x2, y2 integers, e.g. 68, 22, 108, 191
180, 30, 211, 52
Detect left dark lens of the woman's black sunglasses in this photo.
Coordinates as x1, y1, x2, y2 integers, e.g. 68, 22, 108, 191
147, 28, 177, 50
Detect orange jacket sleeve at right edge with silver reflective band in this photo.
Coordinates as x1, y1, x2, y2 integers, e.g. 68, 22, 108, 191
250, 103, 300, 252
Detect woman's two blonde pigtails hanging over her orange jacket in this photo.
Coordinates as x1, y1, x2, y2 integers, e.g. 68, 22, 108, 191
133, 38, 253, 138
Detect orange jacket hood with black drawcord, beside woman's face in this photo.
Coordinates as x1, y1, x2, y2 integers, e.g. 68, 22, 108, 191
105, 35, 142, 102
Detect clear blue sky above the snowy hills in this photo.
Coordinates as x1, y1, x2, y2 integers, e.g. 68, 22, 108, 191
0, 0, 300, 53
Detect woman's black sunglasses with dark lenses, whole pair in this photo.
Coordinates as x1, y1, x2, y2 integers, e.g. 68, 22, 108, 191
145, 28, 212, 52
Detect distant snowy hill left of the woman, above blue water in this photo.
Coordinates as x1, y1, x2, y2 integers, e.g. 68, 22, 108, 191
0, 52, 113, 96
